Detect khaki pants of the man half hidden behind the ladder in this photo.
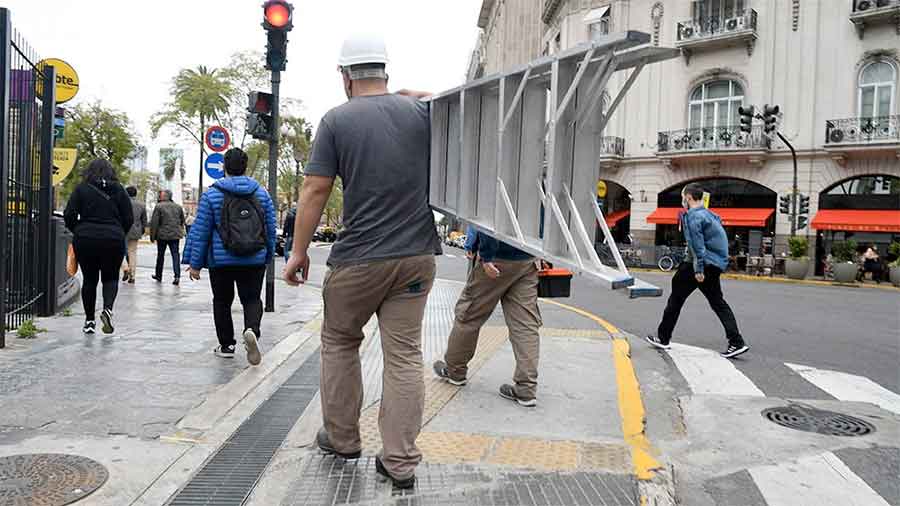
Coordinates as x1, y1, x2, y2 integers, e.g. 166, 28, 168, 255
444, 260, 542, 399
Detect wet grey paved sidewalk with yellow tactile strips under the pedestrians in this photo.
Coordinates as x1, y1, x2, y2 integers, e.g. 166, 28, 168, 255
0, 270, 667, 506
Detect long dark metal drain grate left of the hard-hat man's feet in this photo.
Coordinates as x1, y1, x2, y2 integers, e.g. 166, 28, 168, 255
169, 351, 319, 506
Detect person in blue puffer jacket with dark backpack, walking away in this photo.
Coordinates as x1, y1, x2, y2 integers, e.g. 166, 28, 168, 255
185, 148, 275, 365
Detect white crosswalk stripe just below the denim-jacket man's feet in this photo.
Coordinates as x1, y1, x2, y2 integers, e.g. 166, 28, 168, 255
669, 343, 765, 397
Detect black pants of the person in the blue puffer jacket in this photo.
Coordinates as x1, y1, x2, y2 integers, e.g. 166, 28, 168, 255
209, 265, 266, 347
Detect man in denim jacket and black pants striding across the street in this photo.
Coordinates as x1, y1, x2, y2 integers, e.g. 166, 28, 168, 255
646, 183, 750, 358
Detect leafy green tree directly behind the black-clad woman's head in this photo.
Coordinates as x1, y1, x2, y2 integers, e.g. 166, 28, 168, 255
59, 100, 138, 201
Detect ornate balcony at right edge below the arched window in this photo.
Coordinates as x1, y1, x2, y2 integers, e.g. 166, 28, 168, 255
825, 116, 900, 166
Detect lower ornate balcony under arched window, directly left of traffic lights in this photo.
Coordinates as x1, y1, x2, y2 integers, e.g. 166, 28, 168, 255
656, 125, 772, 168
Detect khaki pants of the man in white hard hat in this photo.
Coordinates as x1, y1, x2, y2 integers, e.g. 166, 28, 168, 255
320, 255, 435, 480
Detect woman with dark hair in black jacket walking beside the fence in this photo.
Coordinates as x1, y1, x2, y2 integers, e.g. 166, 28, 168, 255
65, 159, 134, 334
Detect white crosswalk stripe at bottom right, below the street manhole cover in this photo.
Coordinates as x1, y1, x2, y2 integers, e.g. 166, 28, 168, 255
749, 452, 888, 506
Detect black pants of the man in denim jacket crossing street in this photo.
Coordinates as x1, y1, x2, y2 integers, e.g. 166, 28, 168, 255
656, 262, 744, 346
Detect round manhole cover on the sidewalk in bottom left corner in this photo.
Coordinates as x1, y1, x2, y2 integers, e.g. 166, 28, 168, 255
0, 453, 109, 506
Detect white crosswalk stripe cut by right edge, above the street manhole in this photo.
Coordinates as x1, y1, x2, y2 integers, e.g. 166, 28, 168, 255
784, 363, 900, 414
